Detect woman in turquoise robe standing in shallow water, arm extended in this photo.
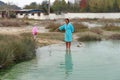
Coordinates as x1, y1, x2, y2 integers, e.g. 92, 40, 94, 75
57, 18, 74, 50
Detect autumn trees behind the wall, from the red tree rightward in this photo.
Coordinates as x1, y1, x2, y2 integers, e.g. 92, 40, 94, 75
80, 0, 120, 12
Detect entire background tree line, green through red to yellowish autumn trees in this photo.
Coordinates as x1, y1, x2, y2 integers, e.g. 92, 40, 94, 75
24, 0, 120, 14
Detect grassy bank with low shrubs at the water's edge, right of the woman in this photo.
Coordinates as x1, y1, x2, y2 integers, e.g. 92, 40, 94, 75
76, 31, 120, 42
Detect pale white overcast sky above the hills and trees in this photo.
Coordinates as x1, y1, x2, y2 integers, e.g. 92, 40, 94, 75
0, 0, 74, 7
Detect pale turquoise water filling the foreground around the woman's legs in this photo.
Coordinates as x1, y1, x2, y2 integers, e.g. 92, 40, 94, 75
1, 41, 120, 80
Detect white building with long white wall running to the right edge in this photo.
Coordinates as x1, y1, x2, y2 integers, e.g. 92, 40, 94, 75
16, 9, 120, 20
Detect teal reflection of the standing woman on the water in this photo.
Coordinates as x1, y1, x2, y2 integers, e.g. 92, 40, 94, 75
65, 50, 73, 77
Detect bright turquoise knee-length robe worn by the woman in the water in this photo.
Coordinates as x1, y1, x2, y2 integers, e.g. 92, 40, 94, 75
59, 23, 74, 42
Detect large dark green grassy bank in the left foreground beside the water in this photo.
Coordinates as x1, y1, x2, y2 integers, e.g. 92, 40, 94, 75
0, 35, 35, 70
